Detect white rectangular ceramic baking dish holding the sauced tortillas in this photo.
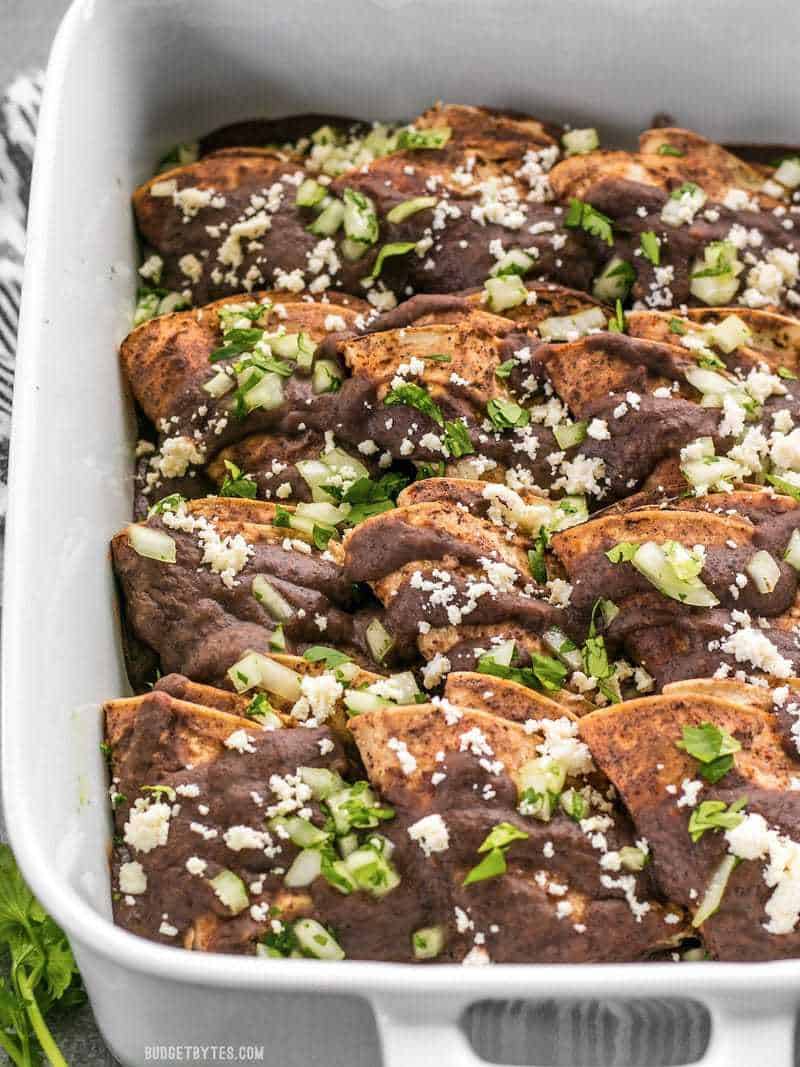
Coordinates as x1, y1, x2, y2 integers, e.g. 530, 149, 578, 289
2, 0, 800, 1067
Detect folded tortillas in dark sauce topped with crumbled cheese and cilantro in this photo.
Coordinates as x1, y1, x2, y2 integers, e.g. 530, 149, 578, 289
103, 105, 800, 966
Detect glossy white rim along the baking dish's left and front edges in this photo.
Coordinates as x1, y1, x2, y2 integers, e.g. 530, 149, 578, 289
2, 0, 800, 1049
